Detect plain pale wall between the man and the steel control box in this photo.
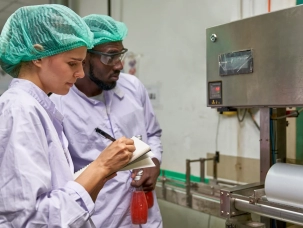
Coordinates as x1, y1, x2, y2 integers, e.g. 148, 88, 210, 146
122, 0, 259, 175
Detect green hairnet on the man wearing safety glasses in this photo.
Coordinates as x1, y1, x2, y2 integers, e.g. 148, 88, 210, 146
83, 14, 127, 46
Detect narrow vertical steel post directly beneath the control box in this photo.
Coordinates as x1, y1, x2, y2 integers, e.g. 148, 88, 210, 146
260, 108, 271, 182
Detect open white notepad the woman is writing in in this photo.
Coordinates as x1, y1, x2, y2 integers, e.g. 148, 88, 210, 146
74, 136, 155, 179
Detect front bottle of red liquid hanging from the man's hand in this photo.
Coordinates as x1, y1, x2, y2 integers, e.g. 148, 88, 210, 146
130, 187, 148, 224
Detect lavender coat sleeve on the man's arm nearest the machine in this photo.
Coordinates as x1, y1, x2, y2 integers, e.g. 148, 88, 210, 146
139, 82, 163, 164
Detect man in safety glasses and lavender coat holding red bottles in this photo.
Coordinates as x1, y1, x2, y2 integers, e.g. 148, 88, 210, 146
51, 15, 162, 228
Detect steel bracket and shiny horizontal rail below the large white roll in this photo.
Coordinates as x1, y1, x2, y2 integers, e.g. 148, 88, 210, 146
220, 183, 303, 228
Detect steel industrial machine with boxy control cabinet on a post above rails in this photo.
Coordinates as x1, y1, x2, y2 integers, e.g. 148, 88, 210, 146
206, 3, 303, 228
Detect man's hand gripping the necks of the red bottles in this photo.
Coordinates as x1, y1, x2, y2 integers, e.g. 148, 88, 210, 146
131, 158, 160, 192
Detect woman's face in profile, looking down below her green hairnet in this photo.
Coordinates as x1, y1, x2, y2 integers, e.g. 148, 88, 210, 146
38, 46, 87, 95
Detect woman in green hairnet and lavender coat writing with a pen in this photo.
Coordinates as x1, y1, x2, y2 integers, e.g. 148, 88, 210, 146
0, 4, 135, 228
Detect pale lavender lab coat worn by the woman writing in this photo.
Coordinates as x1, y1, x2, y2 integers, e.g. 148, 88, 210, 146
0, 107, 94, 228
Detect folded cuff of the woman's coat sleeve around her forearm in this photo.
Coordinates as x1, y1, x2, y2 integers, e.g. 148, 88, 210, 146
65, 181, 95, 215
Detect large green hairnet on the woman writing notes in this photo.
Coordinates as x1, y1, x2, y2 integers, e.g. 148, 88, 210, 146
0, 4, 93, 77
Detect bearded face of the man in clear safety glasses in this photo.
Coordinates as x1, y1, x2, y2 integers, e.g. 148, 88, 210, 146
84, 42, 124, 90
